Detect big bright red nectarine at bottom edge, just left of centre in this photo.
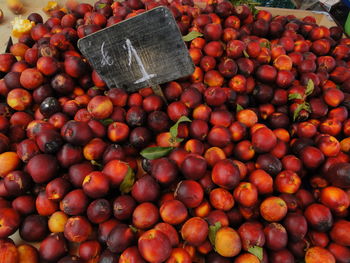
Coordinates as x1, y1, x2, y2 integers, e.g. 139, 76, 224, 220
138, 229, 171, 263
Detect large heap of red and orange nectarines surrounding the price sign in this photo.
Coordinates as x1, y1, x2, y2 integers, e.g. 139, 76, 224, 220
0, 0, 350, 263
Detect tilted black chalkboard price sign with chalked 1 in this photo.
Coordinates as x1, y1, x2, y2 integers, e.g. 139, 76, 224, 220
78, 7, 194, 92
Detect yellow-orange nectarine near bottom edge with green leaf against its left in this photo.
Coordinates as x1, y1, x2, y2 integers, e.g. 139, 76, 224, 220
215, 227, 242, 257
